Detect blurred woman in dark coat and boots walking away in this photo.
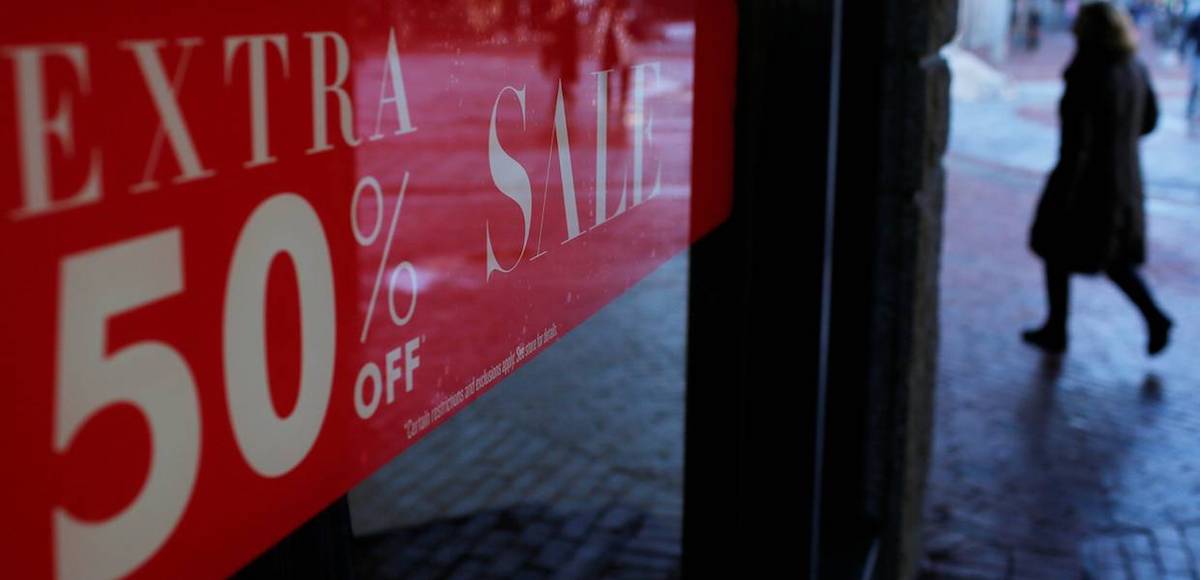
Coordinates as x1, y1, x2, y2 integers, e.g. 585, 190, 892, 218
1024, 2, 1171, 354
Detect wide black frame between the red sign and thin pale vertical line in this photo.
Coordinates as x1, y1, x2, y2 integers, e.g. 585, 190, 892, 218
684, 0, 835, 578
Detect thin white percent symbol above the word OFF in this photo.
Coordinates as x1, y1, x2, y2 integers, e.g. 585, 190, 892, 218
350, 172, 416, 342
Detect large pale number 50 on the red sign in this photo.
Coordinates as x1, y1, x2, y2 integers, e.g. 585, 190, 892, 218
53, 193, 336, 578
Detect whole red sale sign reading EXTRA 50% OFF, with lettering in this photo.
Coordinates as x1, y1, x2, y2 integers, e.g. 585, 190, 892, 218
0, 0, 734, 578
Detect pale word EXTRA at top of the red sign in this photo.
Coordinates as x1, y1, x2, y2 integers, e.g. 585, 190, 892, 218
0, 28, 418, 220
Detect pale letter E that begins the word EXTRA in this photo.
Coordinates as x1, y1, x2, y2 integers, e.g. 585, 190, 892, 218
4, 44, 101, 219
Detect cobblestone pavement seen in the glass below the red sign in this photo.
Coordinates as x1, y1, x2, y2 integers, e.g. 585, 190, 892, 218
350, 255, 688, 579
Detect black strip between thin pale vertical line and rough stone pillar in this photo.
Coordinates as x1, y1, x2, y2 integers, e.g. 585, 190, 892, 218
820, 0, 889, 578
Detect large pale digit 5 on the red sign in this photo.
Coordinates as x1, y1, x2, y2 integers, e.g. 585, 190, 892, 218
54, 228, 200, 579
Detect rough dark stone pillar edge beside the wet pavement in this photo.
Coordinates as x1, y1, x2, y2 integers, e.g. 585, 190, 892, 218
871, 0, 958, 578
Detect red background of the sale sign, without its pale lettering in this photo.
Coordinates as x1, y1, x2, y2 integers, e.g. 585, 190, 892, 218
0, 1, 736, 578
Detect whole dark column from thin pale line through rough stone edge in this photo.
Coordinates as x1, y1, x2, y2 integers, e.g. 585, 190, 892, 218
822, 0, 958, 578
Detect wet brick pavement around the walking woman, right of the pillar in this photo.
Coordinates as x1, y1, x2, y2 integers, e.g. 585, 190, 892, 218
924, 32, 1200, 579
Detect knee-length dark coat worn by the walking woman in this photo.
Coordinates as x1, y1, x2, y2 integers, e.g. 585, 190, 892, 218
1030, 54, 1158, 273
